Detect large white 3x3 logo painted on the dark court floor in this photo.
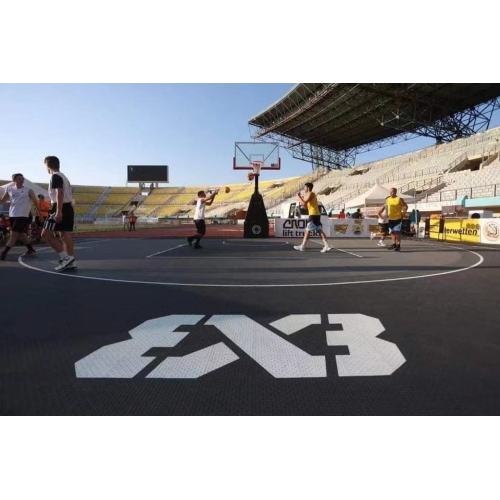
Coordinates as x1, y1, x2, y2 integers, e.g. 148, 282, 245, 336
75, 314, 406, 379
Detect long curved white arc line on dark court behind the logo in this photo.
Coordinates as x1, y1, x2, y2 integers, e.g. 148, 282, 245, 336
18, 249, 484, 288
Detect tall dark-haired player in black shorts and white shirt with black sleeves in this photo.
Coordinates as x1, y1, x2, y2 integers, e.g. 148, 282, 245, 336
42, 156, 76, 271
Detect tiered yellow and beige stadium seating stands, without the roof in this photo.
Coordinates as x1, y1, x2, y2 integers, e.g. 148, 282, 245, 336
0, 127, 500, 222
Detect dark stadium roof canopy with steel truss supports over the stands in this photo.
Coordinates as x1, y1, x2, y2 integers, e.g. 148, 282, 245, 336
249, 83, 500, 167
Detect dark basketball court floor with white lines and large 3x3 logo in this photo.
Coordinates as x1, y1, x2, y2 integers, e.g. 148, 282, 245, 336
0, 237, 500, 415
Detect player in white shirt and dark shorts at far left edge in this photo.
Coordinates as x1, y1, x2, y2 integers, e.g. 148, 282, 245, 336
0, 174, 38, 260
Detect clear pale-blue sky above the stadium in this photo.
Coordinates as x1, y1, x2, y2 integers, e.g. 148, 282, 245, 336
0, 83, 500, 186
